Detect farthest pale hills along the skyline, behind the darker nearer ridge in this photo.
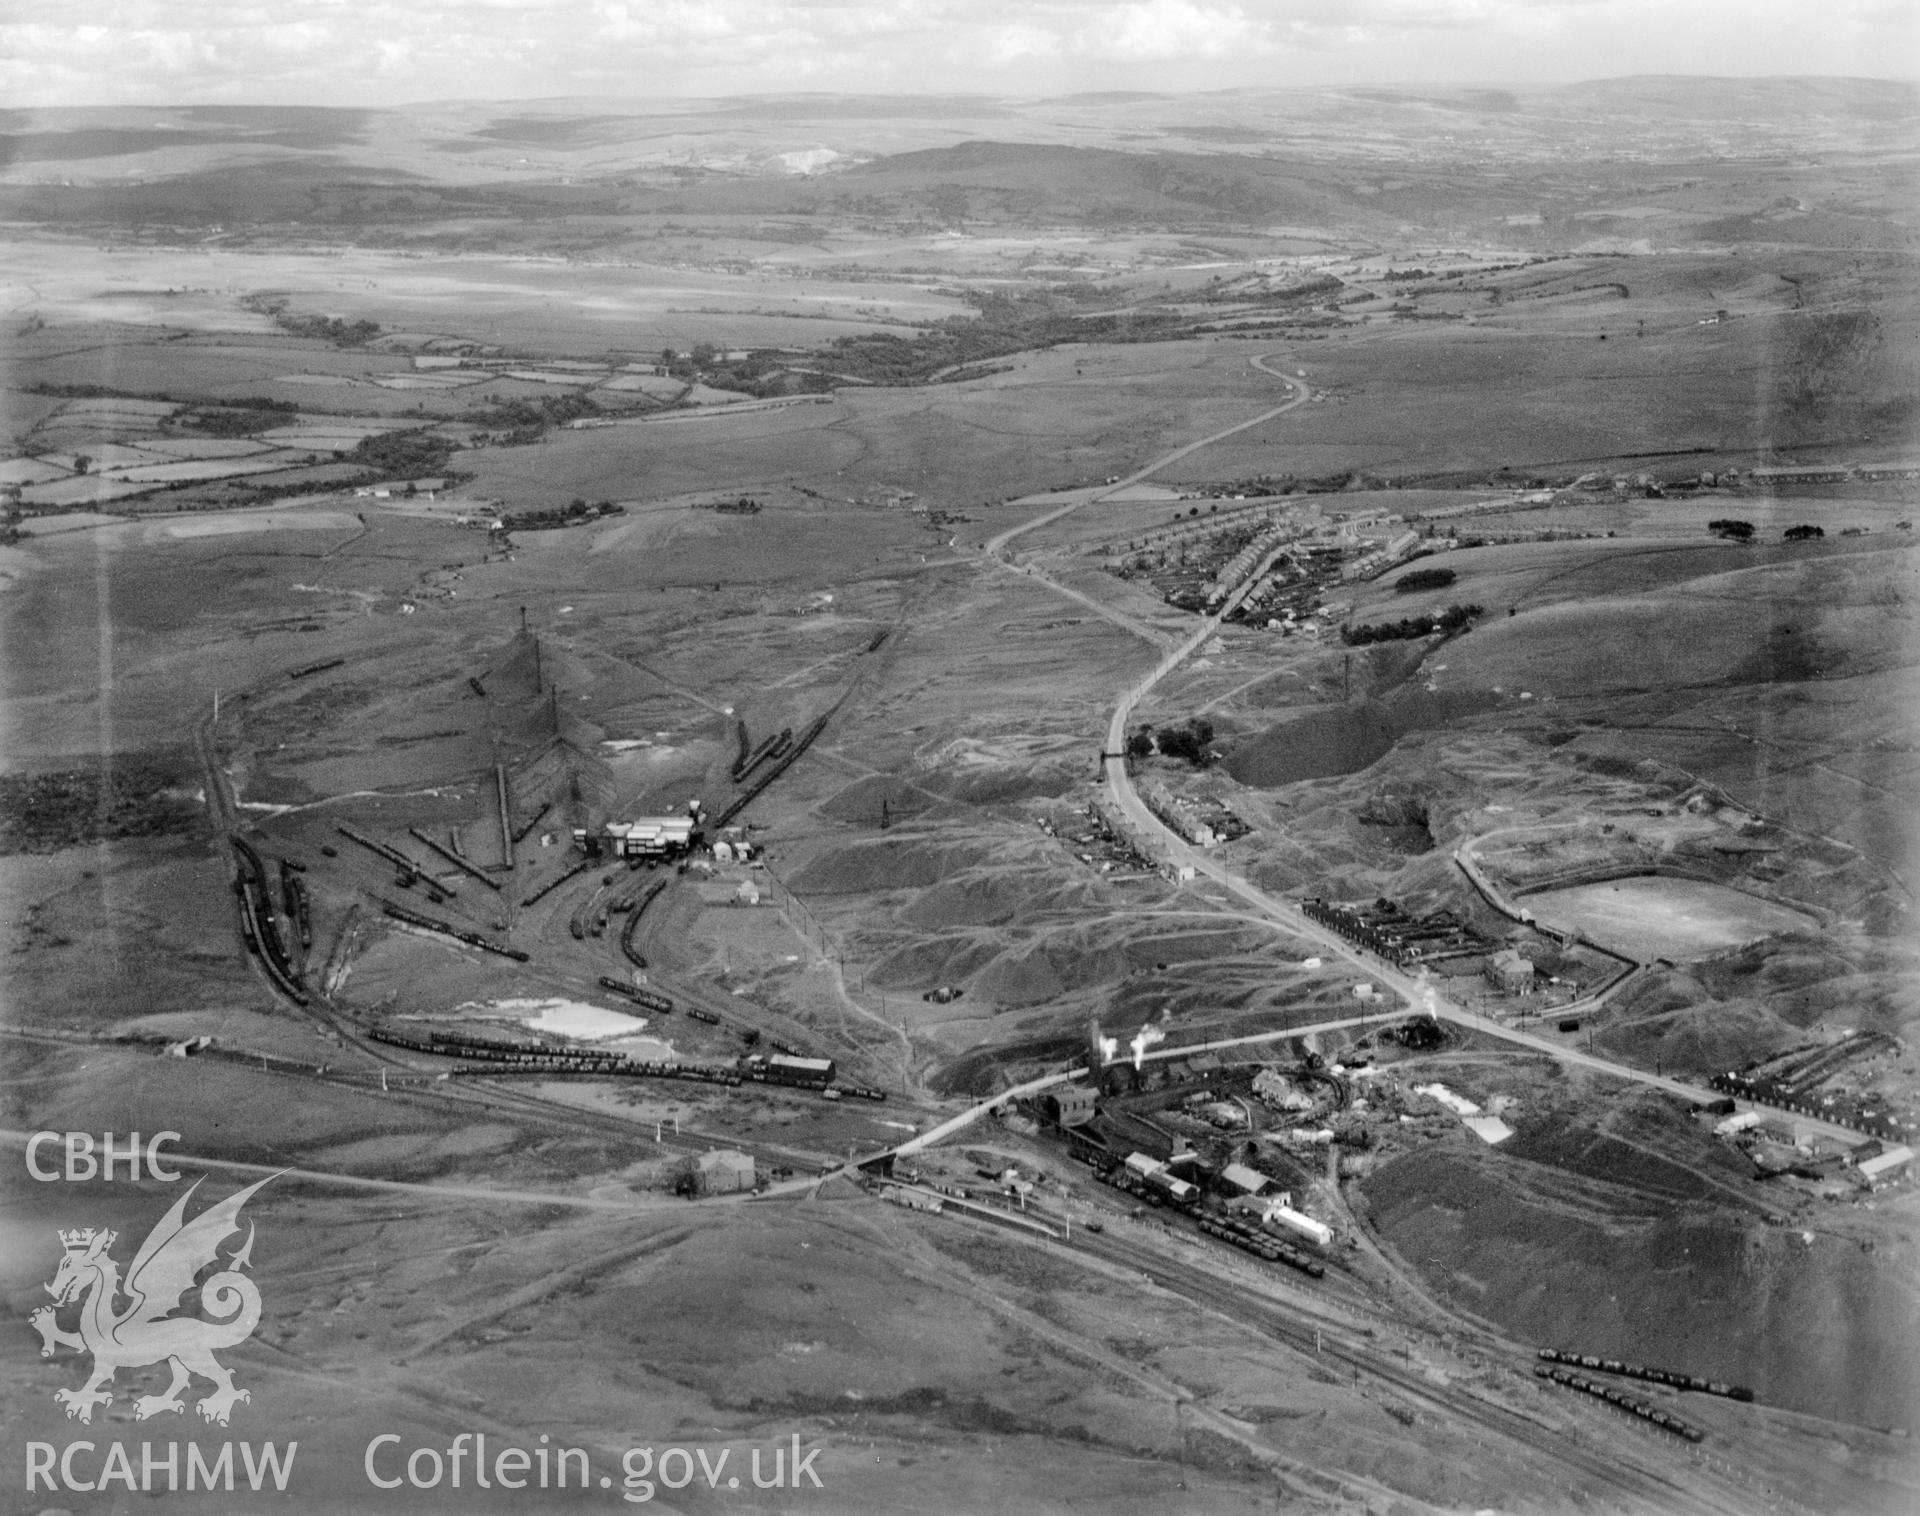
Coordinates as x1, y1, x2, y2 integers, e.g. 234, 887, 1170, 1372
0, 75, 1920, 177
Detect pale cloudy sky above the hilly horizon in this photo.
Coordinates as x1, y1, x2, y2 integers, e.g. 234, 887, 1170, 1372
0, 0, 1920, 107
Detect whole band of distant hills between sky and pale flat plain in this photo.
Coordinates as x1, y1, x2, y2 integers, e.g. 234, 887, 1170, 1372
0, 75, 1920, 251
